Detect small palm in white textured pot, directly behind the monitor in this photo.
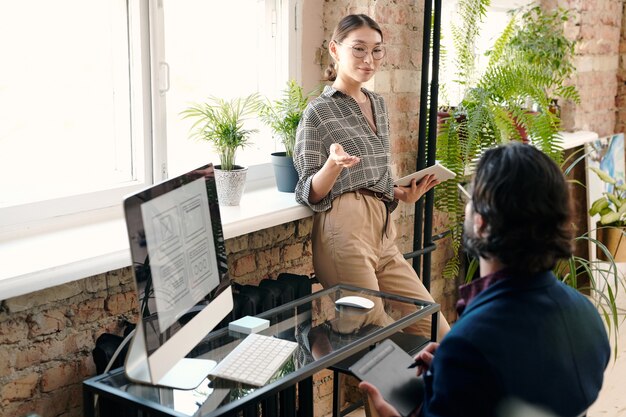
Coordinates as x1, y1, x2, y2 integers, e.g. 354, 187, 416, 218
181, 94, 258, 206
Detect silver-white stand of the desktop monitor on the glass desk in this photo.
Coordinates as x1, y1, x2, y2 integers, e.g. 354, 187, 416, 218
126, 321, 217, 390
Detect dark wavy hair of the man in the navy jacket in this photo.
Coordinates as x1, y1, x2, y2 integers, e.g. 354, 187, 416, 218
464, 142, 573, 273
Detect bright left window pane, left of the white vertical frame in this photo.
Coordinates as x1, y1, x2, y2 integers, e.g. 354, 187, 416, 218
0, 0, 144, 231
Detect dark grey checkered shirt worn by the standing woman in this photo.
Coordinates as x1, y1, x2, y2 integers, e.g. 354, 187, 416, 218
294, 86, 393, 212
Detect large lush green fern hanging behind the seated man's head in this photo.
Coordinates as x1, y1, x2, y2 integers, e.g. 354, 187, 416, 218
436, 0, 579, 278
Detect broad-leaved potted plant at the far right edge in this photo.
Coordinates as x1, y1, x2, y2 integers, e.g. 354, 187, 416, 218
589, 167, 626, 262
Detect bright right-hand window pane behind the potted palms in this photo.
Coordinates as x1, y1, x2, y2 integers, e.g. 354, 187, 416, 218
160, 0, 287, 175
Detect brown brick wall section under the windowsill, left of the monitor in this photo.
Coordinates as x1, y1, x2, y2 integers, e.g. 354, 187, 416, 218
0, 268, 136, 417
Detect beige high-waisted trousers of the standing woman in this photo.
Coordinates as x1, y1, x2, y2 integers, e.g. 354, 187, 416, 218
312, 192, 450, 341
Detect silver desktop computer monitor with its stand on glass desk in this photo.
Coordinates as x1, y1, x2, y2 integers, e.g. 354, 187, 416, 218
124, 164, 233, 389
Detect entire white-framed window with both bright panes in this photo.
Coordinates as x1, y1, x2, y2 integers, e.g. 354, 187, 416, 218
0, 0, 292, 229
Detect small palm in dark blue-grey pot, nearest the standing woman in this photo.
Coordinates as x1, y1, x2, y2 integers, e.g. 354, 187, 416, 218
258, 80, 314, 193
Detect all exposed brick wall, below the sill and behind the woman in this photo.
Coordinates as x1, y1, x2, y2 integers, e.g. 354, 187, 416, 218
0, 0, 626, 417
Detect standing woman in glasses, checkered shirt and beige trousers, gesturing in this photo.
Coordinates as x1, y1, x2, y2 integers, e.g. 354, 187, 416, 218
294, 14, 449, 339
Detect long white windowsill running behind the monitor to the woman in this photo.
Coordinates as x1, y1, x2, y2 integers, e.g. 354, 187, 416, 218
0, 184, 313, 300
